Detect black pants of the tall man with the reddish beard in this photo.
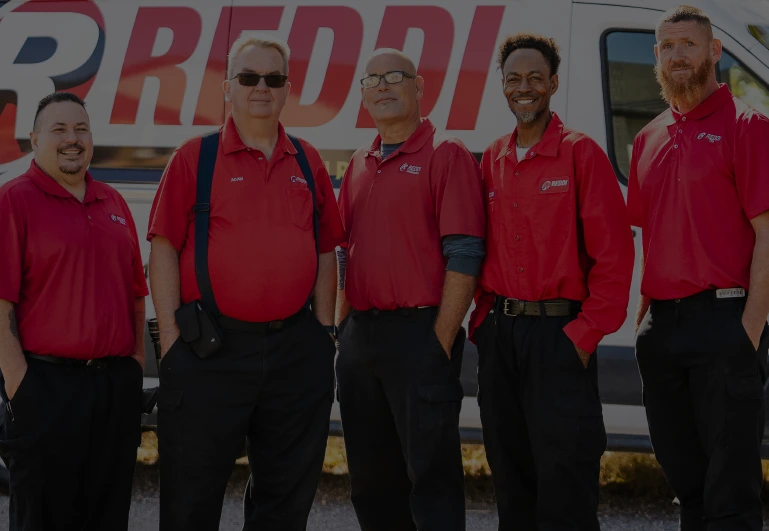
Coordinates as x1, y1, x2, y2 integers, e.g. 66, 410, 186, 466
636, 292, 769, 531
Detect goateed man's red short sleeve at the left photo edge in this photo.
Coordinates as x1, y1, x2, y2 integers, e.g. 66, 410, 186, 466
0, 185, 26, 304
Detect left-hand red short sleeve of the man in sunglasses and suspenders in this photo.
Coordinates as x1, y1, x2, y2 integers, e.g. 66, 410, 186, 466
147, 142, 200, 252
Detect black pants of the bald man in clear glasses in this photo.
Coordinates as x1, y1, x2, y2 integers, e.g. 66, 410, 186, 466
337, 308, 465, 531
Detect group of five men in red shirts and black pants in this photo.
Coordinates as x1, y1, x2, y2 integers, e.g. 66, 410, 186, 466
0, 6, 769, 531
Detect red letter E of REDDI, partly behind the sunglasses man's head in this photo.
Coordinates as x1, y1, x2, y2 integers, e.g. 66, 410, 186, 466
193, 6, 283, 125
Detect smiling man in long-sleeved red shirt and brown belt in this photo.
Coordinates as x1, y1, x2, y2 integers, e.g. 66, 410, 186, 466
470, 34, 634, 531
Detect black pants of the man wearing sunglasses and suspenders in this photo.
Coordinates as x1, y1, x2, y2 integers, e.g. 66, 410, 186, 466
158, 311, 336, 531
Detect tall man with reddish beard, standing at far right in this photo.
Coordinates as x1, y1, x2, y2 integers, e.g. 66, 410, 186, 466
628, 7, 769, 531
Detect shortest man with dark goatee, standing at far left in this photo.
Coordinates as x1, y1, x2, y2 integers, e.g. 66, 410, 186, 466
0, 93, 148, 531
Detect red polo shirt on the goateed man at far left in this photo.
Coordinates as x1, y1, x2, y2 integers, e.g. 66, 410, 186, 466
0, 162, 148, 359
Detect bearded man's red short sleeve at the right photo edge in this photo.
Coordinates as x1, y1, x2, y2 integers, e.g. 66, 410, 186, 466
734, 113, 769, 219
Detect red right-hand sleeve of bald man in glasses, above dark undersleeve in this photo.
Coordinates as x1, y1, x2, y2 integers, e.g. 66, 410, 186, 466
433, 144, 486, 238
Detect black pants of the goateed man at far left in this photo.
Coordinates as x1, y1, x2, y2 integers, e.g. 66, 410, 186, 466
0, 358, 142, 531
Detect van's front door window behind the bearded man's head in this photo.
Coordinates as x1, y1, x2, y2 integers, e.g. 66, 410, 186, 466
601, 31, 769, 184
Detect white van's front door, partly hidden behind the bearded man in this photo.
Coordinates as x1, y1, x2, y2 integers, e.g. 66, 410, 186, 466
568, 2, 769, 446
